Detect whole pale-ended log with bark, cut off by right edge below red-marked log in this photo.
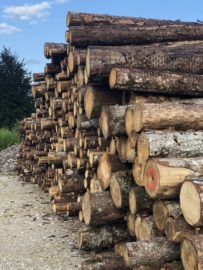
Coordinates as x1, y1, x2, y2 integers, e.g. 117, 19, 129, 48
180, 177, 203, 226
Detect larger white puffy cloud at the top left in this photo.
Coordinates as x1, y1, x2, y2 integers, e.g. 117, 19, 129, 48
3, 1, 51, 21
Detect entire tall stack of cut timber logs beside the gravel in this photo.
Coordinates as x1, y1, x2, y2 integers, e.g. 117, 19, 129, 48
19, 12, 203, 270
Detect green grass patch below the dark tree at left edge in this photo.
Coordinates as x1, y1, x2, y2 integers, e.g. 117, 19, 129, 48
0, 128, 20, 151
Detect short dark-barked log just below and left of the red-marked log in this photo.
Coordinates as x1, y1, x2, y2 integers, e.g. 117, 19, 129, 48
129, 186, 152, 215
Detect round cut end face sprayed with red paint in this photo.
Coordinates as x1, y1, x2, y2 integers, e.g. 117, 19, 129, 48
143, 160, 159, 198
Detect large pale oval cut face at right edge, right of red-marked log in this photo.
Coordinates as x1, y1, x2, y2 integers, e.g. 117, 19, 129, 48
180, 181, 201, 226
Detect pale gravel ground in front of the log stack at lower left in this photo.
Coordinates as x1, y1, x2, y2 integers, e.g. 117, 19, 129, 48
0, 172, 87, 270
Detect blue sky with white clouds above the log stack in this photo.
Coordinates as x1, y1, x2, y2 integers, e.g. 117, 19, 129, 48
0, 0, 203, 72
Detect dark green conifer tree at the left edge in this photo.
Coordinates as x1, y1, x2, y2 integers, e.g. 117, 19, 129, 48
0, 47, 34, 128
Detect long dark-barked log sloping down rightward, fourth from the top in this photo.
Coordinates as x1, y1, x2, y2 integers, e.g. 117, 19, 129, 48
109, 68, 203, 97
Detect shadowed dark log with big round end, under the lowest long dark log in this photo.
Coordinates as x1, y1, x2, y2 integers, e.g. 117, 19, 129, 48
84, 86, 122, 119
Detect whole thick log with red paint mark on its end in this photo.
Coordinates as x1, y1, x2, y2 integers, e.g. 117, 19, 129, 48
144, 158, 203, 198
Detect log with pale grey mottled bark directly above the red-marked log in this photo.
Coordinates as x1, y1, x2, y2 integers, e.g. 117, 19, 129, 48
137, 130, 203, 161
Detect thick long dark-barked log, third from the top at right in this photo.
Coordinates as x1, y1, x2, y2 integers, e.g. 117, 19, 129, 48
86, 41, 203, 80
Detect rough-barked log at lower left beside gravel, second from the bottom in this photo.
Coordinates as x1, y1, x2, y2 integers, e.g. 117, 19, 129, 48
79, 225, 129, 251
